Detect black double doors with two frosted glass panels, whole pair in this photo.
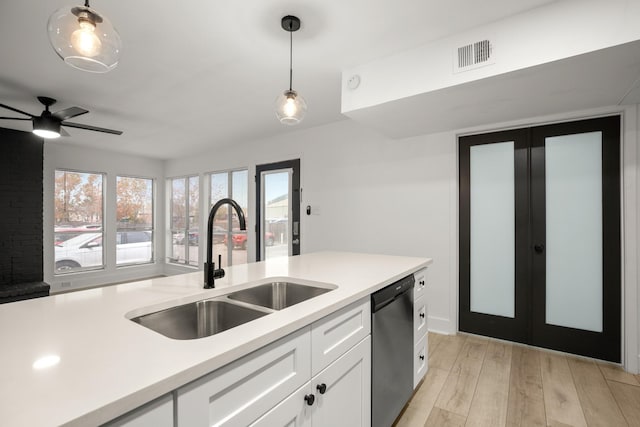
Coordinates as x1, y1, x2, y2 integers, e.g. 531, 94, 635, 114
459, 116, 621, 362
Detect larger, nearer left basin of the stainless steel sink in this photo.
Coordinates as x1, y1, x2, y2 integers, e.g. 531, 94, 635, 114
131, 300, 268, 340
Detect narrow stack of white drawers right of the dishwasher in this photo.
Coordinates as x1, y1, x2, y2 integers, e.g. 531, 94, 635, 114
413, 268, 429, 388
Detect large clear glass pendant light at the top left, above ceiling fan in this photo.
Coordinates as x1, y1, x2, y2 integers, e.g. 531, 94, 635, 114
47, 0, 122, 73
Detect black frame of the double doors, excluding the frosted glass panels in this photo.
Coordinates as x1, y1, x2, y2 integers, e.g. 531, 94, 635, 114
458, 115, 624, 362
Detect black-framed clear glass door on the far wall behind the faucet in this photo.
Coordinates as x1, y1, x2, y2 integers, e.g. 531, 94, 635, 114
256, 159, 301, 261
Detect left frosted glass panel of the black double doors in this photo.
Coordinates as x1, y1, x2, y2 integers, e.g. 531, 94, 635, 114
470, 141, 515, 318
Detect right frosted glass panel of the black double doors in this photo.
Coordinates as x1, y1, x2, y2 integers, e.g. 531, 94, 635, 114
545, 132, 602, 332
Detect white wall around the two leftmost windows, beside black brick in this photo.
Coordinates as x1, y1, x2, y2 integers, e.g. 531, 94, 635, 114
43, 141, 165, 293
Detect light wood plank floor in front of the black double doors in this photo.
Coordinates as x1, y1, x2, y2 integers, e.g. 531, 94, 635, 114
396, 333, 640, 427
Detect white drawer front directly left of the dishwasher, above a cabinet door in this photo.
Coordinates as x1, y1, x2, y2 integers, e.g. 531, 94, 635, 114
311, 297, 371, 375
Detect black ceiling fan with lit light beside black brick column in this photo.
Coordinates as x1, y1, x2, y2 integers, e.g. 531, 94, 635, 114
0, 96, 122, 139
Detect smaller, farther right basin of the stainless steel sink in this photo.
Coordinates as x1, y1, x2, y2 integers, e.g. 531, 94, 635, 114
227, 282, 331, 310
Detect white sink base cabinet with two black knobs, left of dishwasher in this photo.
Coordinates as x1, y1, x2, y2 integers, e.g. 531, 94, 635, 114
176, 297, 371, 427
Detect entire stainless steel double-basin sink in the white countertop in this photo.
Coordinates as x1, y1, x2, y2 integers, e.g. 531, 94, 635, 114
131, 281, 332, 340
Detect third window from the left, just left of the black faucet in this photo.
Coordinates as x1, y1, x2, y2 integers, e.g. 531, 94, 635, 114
168, 176, 200, 266
